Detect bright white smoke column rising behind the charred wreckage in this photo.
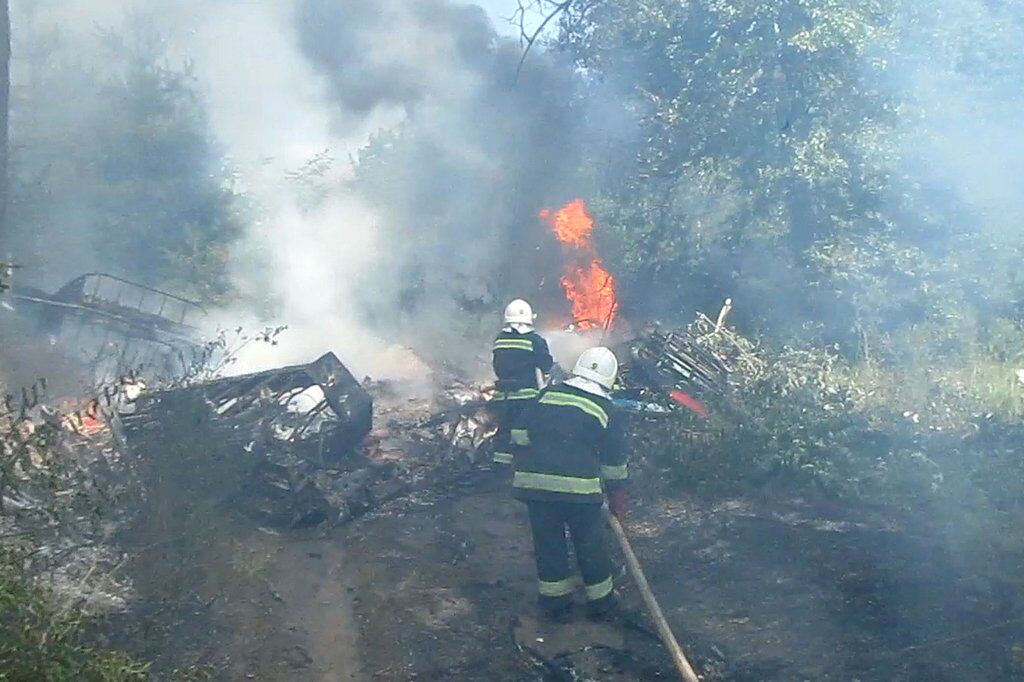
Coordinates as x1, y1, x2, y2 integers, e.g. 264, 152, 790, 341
169, 0, 423, 377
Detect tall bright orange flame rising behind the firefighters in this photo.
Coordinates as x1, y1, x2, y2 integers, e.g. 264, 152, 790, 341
541, 199, 618, 330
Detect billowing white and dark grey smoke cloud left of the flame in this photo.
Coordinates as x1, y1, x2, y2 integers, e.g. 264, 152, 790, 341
202, 0, 598, 376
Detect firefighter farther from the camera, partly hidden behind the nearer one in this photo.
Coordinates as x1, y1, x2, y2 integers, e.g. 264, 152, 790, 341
493, 299, 554, 464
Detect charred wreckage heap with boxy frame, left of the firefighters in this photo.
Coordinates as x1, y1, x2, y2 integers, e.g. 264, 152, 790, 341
119, 353, 494, 528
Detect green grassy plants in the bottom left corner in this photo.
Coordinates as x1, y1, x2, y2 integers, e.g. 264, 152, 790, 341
0, 551, 148, 682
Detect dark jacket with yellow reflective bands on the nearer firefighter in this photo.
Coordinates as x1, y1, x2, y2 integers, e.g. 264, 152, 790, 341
512, 384, 628, 504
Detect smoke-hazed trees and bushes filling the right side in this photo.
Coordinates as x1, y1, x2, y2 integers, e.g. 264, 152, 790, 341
558, 0, 1024, 540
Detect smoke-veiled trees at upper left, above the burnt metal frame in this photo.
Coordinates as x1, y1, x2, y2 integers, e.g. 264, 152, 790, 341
9, 15, 243, 301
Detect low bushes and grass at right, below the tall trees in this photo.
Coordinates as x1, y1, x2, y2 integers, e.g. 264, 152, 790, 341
634, 317, 1024, 515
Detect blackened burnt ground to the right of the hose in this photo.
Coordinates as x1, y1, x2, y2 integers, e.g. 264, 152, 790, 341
636, 491, 1024, 681
